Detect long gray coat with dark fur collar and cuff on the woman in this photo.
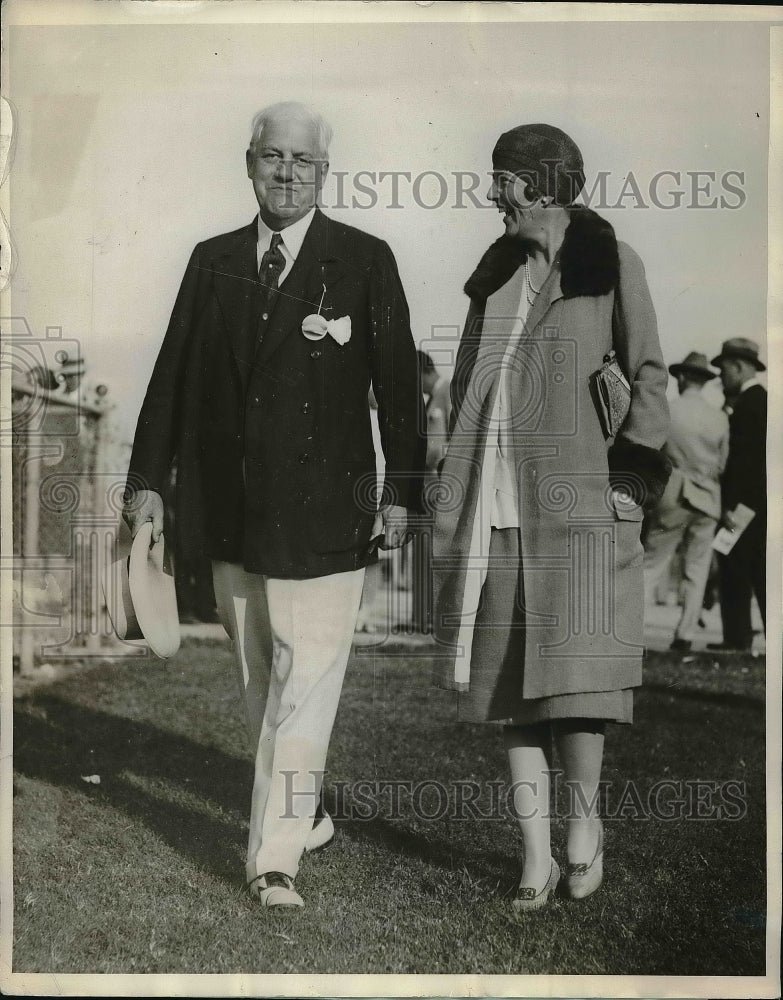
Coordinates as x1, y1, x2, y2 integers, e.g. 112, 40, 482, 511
433, 209, 669, 698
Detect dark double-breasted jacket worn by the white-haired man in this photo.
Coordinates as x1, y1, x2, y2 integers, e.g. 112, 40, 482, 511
129, 209, 426, 578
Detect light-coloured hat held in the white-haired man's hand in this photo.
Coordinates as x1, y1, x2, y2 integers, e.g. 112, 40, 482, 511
103, 521, 180, 660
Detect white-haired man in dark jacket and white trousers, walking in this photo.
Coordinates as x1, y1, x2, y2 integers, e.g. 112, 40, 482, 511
126, 103, 425, 906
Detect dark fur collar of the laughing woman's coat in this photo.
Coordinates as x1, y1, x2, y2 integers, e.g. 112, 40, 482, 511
465, 205, 620, 301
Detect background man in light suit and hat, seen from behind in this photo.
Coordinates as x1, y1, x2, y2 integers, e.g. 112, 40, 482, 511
644, 351, 729, 653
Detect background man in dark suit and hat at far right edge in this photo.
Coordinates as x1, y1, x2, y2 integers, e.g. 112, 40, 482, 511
708, 337, 767, 651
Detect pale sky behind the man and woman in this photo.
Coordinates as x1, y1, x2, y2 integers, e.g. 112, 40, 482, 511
6, 5, 769, 439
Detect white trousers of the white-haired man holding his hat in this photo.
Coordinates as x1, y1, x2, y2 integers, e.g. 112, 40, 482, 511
212, 562, 364, 882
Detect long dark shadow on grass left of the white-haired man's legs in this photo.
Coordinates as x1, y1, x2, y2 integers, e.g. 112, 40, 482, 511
14, 693, 253, 883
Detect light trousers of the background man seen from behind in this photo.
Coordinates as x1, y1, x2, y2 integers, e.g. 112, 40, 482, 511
644, 502, 718, 642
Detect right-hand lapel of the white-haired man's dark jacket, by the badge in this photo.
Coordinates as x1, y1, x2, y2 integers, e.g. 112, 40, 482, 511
255, 209, 345, 364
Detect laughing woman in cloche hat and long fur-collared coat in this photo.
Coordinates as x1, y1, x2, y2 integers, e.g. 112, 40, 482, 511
434, 125, 669, 910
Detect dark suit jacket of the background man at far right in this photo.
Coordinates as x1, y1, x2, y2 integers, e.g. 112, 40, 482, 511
721, 385, 767, 528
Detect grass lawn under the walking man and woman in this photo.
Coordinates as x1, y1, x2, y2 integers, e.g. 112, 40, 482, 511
13, 641, 766, 975
